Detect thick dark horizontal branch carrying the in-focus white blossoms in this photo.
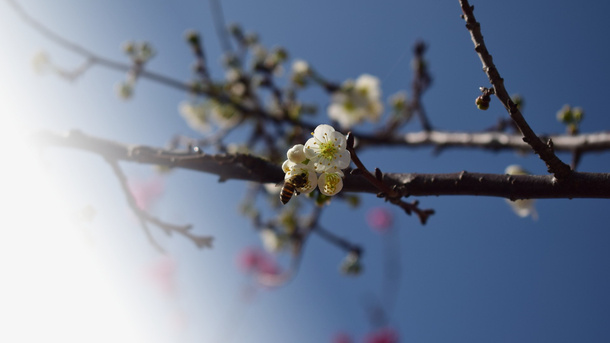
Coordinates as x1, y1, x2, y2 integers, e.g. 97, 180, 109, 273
35, 131, 610, 200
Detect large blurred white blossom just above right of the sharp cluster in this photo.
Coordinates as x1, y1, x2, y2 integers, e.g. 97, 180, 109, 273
328, 74, 383, 128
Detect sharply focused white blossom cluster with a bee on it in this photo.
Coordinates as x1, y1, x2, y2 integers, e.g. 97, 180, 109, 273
282, 124, 351, 203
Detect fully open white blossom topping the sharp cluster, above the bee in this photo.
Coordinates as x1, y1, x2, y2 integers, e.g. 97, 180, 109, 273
305, 124, 351, 173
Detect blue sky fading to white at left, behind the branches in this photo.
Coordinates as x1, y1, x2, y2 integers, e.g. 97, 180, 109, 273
0, 0, 610, 342
